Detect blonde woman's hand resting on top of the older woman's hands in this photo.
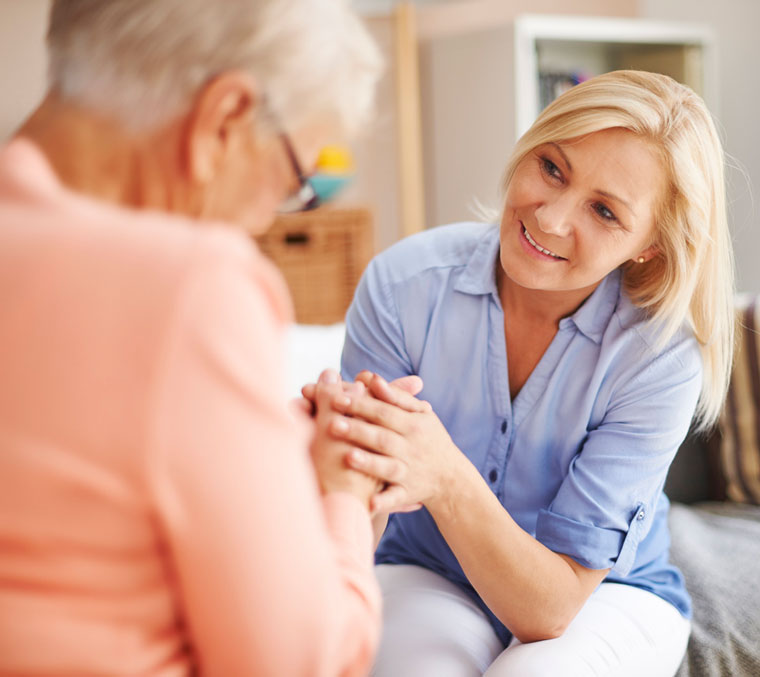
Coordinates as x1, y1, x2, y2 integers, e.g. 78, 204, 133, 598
330, 375, 467, 512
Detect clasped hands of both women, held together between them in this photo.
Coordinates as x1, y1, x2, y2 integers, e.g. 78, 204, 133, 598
302, 370, 464, 514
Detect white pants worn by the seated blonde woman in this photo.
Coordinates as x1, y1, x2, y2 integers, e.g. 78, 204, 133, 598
372, 564, 691, 677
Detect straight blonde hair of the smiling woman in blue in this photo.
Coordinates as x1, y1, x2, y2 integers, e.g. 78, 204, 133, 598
503, 71, 734, 430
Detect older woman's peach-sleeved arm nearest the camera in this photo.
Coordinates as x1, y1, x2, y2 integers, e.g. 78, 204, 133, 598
149, 251, 379, 676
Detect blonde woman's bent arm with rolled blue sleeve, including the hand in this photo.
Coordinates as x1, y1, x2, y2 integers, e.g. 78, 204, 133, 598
334, 348, 700, 642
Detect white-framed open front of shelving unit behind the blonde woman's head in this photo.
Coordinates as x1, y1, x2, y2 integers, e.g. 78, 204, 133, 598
513, 15, 717, 138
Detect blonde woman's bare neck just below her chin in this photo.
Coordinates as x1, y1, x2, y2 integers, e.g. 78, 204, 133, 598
498, 267, 599, 328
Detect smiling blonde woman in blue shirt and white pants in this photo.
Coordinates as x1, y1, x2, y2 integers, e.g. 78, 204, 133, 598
322, 71, 733, 677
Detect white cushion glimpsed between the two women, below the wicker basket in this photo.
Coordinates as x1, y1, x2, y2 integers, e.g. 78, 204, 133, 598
285, 323, 346, 397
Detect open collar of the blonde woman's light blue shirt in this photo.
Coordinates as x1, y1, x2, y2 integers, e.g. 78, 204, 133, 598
454, 226, 621, 343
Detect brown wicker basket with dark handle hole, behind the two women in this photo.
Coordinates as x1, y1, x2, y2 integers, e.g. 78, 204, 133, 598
257, 207, 373, 324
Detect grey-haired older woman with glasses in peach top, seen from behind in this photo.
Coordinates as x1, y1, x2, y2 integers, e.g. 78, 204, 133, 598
0, 0, 386, 677
